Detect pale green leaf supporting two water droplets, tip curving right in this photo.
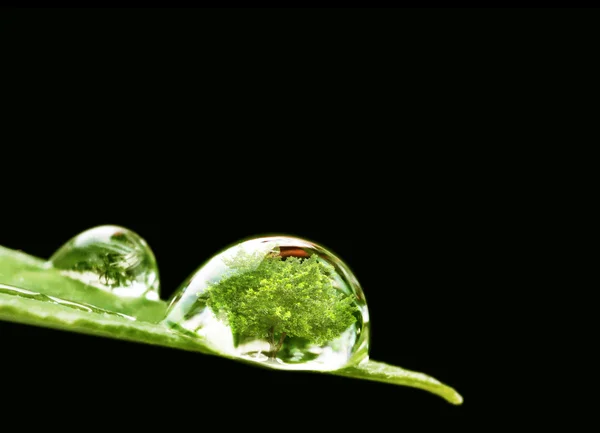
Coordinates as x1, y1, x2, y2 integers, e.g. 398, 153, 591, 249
0, 247, 463, 405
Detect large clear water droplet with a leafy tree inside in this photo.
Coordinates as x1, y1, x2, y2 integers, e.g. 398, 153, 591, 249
163, 236, 369, 371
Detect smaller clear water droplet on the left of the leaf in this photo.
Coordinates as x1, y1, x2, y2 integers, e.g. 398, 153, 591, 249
48, 225, 160, 301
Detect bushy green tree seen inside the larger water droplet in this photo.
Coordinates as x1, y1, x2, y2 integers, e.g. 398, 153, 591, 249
206, 251, 357, 359
